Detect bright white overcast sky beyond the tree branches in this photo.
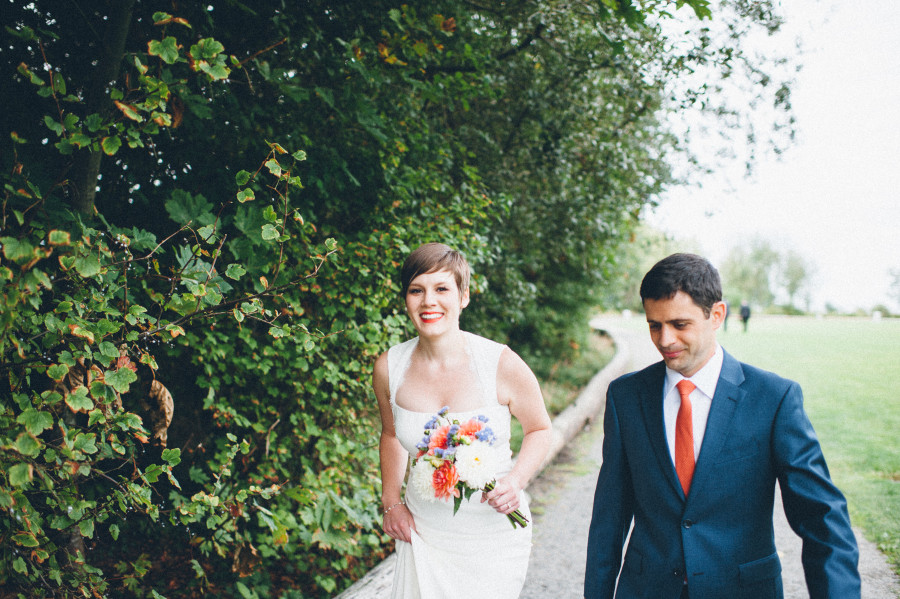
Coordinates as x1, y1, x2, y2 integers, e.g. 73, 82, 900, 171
647, 0, 900, 310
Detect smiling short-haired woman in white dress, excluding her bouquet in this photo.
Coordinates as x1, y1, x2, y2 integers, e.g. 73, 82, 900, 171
372, 243, 550, 599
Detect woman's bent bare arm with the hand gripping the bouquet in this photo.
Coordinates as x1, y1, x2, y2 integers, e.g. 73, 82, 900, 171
486, 348, 551, 514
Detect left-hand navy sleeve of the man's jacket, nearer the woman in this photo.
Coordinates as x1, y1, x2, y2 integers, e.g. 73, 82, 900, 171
584, 388, 634, 599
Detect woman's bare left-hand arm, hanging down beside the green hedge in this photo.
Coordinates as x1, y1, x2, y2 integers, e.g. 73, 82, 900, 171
372, 353, 416, 543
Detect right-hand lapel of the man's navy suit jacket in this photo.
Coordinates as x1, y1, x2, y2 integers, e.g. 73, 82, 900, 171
691, 352, 745, 502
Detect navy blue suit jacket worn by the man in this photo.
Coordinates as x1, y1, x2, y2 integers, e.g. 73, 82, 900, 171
584, 353, 860, 599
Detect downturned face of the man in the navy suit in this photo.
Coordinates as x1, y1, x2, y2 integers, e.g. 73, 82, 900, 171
644, 291, 725, 377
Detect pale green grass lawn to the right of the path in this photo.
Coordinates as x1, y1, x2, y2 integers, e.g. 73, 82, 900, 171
719, 316, 900, 570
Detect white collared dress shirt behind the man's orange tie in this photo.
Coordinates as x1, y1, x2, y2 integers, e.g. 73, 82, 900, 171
663, 344, 725, 464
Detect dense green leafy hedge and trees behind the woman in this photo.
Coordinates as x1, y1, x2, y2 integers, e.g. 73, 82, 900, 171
0, 0, 780, 598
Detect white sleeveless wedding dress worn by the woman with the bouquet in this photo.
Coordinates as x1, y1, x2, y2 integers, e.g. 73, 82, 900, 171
388, 333, 532, 599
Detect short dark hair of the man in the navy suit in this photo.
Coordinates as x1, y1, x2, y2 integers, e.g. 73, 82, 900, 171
641, 254, 722, 318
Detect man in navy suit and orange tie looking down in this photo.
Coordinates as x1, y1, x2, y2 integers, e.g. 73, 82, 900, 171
584, 254, 860, 599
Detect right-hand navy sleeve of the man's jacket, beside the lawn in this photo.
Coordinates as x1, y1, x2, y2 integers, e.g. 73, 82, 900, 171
773, 383, 860, 599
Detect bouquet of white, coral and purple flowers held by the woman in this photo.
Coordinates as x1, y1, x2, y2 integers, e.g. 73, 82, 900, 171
410, 406, 528, 528
